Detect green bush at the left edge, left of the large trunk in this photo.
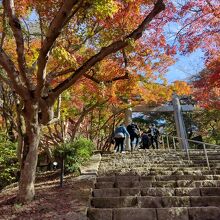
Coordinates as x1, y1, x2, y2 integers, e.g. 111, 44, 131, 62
0, 133, 19, 189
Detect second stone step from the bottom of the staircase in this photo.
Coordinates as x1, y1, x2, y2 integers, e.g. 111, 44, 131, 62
91, 196, 220, 208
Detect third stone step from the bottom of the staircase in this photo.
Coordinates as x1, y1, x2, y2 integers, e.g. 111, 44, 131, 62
92, 187, 220, 197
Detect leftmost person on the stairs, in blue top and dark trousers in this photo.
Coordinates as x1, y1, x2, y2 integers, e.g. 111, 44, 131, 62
114, 124, 130, 153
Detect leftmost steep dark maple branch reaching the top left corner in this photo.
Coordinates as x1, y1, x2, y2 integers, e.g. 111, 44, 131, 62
3, 0, 30, 88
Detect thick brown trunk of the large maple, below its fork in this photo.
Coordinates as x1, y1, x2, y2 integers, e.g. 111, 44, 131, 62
17, 104, 41, 203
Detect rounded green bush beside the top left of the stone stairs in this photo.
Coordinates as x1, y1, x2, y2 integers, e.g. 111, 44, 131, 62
54, 137, 95, 172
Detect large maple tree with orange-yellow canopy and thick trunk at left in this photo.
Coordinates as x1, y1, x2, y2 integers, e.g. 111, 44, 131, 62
0, 0, 217, 202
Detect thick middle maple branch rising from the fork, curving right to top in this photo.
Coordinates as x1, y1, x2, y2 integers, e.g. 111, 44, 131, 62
36, 0, 79, 97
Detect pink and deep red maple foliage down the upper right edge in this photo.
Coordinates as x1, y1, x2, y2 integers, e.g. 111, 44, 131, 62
167, 0, 220, 109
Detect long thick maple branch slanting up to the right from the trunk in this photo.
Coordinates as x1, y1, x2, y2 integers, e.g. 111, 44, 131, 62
50, 0, 165, 99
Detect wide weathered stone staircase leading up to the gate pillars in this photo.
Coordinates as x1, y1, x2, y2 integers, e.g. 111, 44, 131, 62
87, 150, 220, 220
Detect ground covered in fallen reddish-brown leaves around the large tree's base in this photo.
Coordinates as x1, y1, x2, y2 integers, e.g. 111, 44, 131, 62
0, 172, 93, 220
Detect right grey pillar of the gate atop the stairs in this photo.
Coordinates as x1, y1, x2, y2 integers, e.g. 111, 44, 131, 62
172, 94, 189, 151
